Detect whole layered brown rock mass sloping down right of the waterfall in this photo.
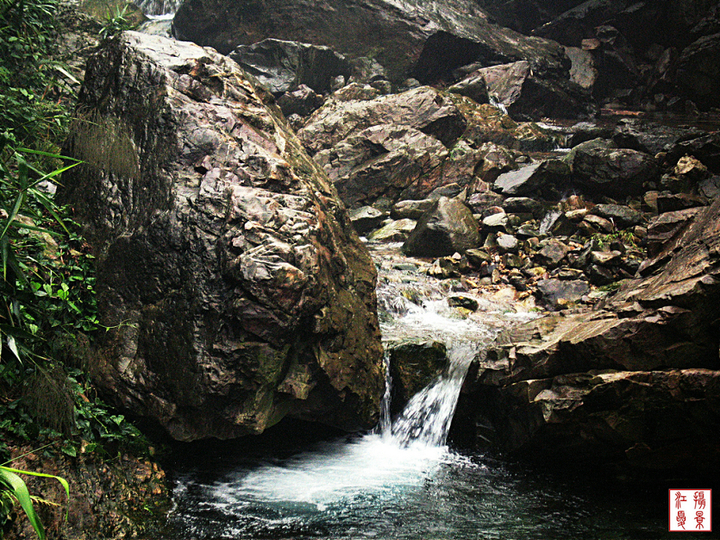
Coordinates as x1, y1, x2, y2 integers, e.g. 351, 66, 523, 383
462, 201, 720, 471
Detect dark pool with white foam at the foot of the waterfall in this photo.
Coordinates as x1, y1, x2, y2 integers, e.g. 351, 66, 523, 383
166, 435, 718, 540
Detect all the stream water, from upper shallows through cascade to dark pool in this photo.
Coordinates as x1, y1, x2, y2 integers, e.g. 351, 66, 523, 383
166, 245, 704, 540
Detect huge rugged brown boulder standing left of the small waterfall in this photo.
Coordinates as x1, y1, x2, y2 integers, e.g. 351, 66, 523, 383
60, 32, 384, 440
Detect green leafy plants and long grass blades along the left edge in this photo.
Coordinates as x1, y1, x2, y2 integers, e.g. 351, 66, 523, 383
0, 0, 160, 538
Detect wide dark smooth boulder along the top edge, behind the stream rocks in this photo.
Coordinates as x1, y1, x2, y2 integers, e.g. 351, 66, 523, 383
173, 0, 569, 83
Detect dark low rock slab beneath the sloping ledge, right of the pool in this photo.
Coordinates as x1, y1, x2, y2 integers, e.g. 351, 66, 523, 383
470, 368, 720, 475
